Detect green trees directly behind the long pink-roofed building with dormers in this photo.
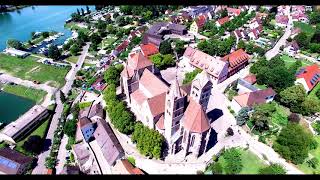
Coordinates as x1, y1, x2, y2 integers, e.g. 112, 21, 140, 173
197, 36, 236, 56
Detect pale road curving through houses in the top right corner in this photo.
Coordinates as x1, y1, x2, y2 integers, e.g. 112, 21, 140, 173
265, 8, 293, 60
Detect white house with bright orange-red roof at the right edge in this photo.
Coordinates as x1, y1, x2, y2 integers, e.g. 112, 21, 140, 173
295, 64, 320, 93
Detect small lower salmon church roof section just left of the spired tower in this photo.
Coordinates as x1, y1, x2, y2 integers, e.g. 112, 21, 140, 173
147, 92, 166, 117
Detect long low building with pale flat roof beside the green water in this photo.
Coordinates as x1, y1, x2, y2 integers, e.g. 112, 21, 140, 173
0, 105, 49, 144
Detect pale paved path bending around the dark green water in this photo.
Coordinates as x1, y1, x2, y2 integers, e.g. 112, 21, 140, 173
0, 74, 57, 107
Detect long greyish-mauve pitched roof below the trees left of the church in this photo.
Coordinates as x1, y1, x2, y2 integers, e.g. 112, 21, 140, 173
94, 119, 124, 166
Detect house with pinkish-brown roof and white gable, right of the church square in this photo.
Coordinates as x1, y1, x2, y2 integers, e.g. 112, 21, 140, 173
231, 88, 276, 113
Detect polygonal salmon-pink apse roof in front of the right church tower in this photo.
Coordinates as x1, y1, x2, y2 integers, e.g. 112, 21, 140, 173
183, 99, 210, 133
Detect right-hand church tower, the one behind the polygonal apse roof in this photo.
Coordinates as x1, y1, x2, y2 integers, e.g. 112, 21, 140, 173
190, 71, 212, 112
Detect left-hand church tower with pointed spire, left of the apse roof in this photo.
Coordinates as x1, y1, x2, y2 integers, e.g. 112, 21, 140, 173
164, 79, 186, 153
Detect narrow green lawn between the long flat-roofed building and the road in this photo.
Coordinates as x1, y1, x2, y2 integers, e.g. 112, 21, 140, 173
15, 116, 51, 154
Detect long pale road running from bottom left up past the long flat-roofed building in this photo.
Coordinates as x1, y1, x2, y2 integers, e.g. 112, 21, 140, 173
32, 43, 90, 174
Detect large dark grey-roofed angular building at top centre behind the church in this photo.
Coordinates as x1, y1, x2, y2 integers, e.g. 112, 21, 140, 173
142, 22, 187, 47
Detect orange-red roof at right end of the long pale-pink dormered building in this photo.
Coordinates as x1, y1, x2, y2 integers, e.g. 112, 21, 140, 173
222, 49, 249, 68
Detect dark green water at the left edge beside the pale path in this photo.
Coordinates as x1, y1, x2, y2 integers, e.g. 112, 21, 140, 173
0, 91, 36, 124
